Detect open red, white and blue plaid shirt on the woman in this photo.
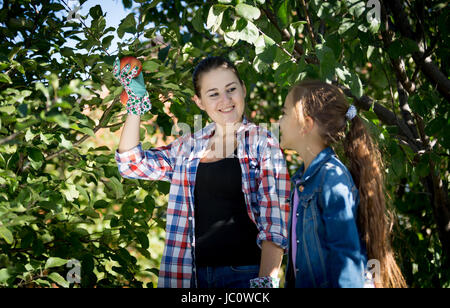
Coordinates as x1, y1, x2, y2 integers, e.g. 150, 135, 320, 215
115, 117, 290, 288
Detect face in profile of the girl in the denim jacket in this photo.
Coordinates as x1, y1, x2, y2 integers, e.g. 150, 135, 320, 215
280, 93, 305, 150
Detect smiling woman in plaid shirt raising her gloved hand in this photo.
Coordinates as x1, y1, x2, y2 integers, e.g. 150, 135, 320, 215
110, 57, 290, 288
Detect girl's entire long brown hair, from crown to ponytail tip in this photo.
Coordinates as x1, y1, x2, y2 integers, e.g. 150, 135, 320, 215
290, 80, 406, 287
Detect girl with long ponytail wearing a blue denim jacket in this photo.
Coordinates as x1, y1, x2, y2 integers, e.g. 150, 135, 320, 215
280, 81, 405, 287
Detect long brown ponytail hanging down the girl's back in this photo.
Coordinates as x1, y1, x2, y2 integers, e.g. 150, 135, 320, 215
343, 116, 406, 288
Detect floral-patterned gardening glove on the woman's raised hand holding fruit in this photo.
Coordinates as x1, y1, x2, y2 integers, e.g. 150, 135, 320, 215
113, 58, 152, 115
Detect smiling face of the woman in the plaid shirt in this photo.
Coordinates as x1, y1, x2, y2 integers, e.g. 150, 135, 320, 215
194, 67, 246, 126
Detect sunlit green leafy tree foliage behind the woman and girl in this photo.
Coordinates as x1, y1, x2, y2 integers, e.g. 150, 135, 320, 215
0, 0, 450, 287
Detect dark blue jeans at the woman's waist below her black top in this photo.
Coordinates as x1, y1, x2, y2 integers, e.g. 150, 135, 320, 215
197, 265, 259, 288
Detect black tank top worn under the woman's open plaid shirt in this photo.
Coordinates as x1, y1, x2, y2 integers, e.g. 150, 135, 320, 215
194, 151, 261, 266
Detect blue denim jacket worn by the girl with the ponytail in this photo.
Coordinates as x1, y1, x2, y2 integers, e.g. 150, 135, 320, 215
286, 148, 367, 288
